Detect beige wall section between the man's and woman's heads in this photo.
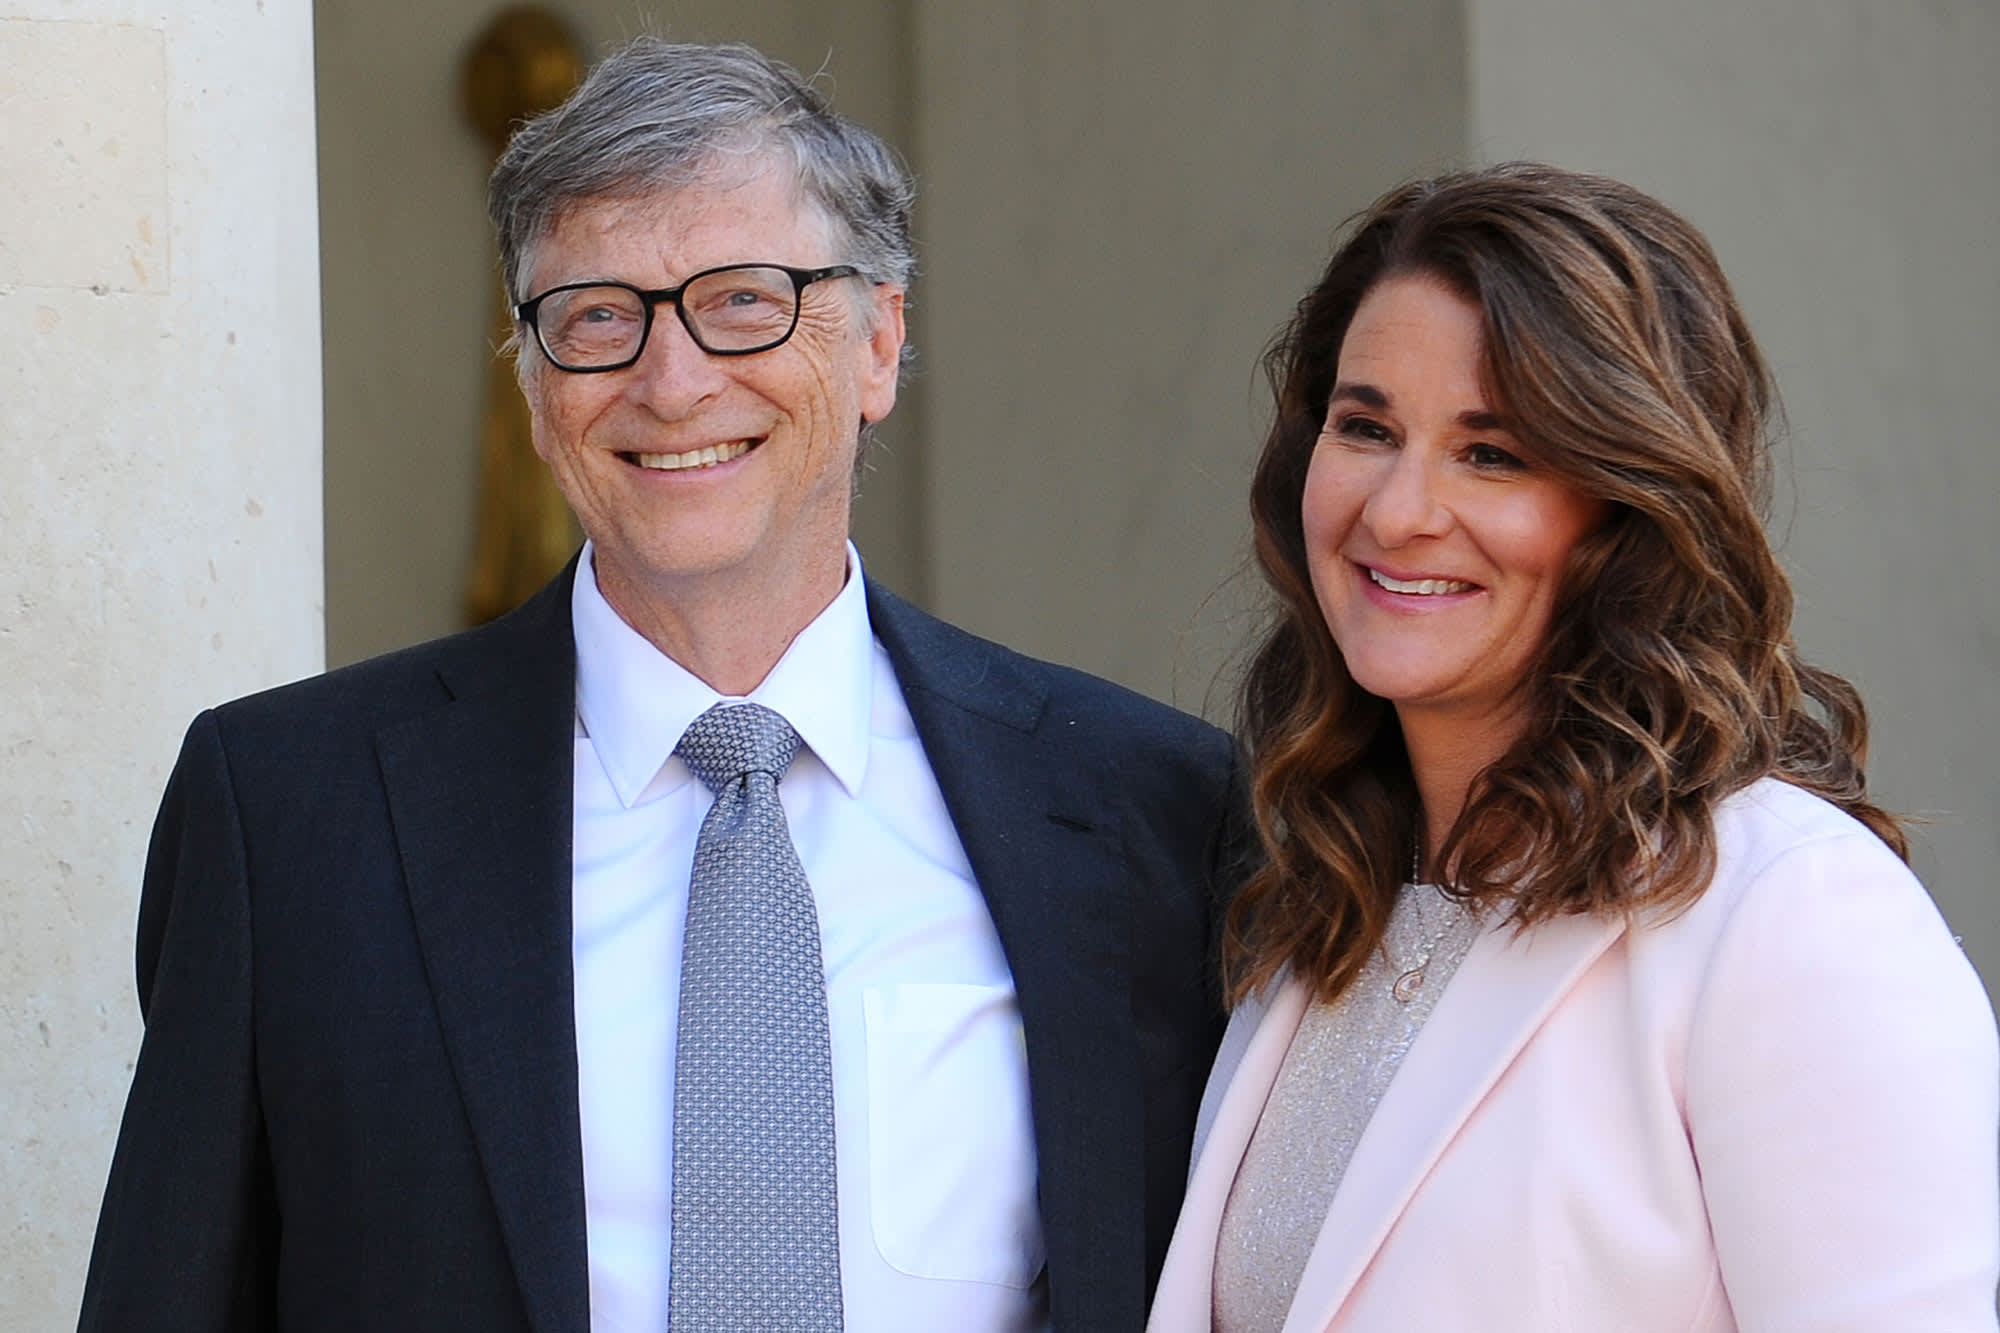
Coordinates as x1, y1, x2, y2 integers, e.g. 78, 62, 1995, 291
916, 0, 1466, 713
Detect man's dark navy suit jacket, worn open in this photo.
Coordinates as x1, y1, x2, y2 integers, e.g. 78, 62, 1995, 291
82, 562, 1244, 1333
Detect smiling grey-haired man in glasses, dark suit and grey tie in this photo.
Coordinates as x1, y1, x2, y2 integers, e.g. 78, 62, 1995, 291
82, 38, 1240, 1333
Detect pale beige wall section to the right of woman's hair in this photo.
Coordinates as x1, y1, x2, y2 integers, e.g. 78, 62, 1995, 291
1470, 0, 2000, 991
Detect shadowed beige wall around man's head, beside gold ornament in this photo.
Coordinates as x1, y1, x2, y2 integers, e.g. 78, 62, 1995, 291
314, 0, 924, 662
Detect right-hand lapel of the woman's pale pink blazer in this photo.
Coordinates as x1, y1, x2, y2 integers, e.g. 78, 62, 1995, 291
1280, 917, 1624, 1333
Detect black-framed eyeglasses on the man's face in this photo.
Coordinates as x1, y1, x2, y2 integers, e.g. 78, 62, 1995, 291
514, 264, 860, 374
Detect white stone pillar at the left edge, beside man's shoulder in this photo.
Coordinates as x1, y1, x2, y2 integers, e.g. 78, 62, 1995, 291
0, 0, 322, 1329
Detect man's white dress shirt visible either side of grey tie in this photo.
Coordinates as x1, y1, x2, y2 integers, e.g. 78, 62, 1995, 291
572, 544, 1048, 1333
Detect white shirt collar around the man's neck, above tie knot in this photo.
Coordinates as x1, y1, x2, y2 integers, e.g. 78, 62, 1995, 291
570, 542, 874, 809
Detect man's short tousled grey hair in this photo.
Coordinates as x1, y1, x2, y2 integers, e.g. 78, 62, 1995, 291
486, 36, 916, 300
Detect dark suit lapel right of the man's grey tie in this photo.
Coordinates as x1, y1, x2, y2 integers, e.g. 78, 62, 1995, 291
868, 584, 1146, 1327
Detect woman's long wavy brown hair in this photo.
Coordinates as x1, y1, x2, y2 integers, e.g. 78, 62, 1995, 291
1224, 162, 1906, 1001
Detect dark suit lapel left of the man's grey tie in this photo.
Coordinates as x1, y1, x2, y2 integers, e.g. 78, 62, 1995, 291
376, 562, 590, 1333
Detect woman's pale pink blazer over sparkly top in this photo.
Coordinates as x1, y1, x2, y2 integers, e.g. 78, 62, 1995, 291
1148, 781, 2000, 1333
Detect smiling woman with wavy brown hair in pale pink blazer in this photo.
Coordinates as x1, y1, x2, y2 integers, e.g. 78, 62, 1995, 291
1152, 164, 2000, 1333
